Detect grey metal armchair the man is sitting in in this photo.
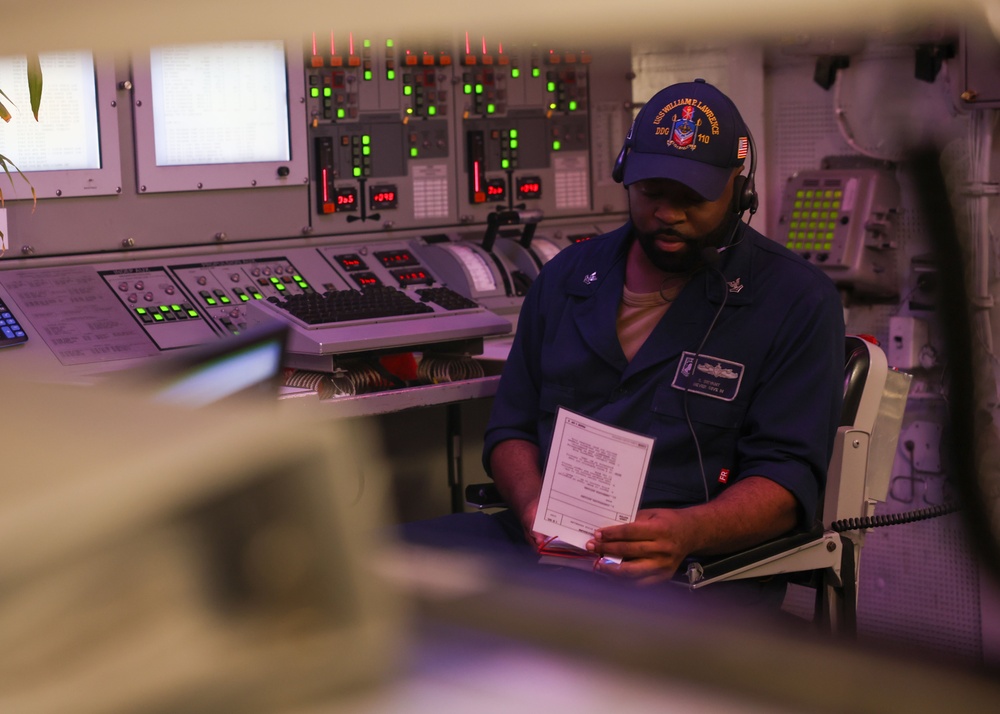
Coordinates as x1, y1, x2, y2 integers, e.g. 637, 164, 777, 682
465, 336, 911, 636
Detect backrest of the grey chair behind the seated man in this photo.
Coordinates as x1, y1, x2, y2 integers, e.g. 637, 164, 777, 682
822, 336, 912, 540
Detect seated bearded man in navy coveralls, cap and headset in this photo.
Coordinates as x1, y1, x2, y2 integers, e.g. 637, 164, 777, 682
408, 80, 844, 599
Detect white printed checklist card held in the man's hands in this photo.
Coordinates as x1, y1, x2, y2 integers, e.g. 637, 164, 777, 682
533, 407, 653, 558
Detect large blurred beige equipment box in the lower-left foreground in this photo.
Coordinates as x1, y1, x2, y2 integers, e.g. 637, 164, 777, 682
0, 375, 402, 714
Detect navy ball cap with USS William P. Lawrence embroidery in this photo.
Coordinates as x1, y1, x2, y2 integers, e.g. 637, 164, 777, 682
622, 79, 750, 201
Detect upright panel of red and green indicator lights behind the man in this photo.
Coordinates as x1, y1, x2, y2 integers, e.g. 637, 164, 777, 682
305, 32, 629, 232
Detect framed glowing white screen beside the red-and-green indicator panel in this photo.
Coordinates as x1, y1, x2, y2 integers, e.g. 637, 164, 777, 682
133, 41, 308, 192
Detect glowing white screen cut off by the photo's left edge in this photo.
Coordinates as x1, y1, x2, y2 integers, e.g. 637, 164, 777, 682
0, 52, 121, 199
